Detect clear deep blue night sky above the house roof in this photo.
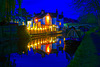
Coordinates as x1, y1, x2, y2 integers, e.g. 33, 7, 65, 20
22, 0, 79, 19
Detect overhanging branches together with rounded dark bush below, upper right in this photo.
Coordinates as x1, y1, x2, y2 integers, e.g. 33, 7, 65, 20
72, 0, 100, 26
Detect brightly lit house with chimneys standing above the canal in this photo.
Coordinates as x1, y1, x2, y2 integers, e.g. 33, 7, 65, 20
26, 10, 64, 33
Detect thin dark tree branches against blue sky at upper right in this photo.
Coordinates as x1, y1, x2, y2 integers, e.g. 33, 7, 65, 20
73, 0, 100, 27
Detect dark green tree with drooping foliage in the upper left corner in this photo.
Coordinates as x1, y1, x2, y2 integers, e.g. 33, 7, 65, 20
0, 0, 16, 22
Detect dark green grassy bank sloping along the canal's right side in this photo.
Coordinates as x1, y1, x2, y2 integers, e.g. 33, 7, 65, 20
68, 27, 100, 67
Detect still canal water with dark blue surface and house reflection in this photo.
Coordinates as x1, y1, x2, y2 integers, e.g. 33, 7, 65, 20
0, 34, 79, 67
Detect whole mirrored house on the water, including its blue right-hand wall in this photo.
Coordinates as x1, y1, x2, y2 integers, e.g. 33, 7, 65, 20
27, 35, 64, 55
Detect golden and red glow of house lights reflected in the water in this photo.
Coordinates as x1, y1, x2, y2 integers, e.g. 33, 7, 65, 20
27, 36, 60, 54
